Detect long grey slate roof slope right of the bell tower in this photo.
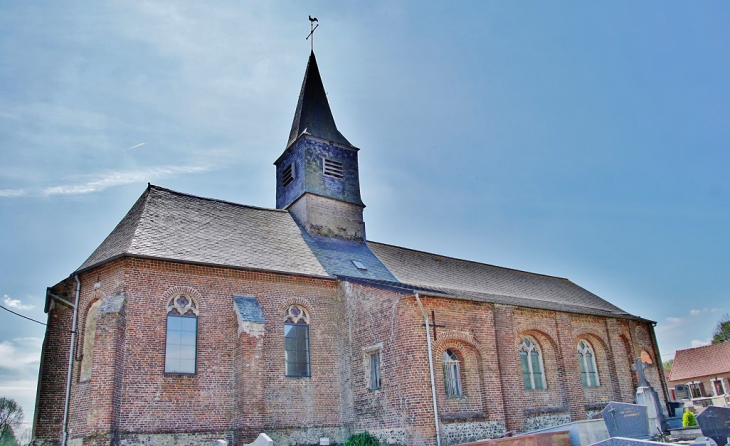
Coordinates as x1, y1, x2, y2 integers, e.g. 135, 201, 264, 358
368, 242, 635, 318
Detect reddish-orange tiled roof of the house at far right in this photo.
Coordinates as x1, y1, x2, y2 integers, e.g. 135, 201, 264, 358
668, 342, 730, 381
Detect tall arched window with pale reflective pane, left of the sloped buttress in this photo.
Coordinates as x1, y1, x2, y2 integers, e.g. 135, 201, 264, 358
165, 294, 198, 375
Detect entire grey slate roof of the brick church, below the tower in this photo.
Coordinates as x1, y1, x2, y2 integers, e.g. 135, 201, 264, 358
77, 185, 636, 318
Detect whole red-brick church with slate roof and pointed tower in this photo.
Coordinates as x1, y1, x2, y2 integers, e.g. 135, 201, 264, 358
33, 52, 667, 446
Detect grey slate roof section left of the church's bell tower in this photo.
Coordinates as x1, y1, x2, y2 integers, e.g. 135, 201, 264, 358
79, 186, 327, 276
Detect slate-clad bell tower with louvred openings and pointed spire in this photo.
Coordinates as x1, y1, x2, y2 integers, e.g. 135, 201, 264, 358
274, 51, 365, 242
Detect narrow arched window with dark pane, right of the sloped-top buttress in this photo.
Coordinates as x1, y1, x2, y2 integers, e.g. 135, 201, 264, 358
284, 305, 310, 377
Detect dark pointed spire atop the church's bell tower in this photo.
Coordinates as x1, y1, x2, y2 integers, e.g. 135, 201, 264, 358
286, 51, 352, 147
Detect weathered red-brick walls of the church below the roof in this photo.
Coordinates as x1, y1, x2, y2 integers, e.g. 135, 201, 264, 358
34, 258, 664, 445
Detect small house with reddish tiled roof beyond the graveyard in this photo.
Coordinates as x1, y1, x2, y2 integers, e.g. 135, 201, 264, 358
667, 342, 730, 406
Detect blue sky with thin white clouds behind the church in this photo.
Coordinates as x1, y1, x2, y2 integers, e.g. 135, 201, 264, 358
0, 0, 730, 430
